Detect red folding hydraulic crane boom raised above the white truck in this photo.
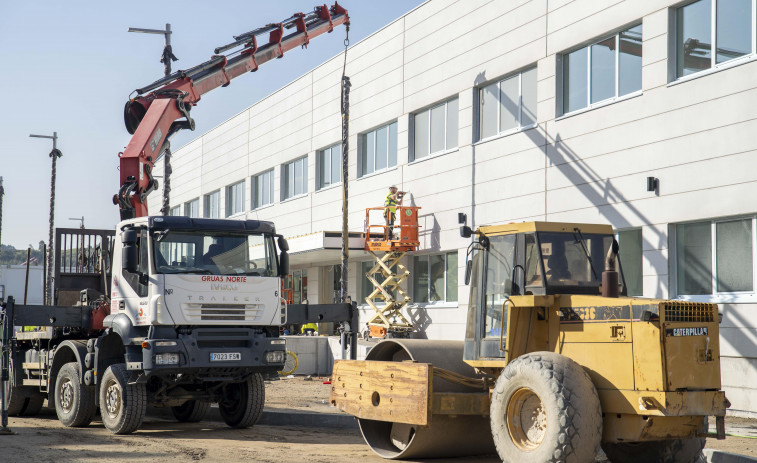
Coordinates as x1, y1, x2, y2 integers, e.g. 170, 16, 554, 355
113, 3, 349, 220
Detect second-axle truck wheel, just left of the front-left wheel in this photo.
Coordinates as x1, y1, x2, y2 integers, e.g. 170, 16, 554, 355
55, 362, 95, 427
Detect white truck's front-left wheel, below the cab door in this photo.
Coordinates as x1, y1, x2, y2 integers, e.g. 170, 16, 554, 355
100, 363, 147, 434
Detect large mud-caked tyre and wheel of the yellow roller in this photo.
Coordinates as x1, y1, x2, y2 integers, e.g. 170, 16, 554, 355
489, 352, 604, 463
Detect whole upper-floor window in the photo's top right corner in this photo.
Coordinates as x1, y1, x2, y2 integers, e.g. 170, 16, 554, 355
675, 0, 754, 78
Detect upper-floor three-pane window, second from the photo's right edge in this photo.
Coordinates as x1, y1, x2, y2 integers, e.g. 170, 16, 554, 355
562, 24, 642, 114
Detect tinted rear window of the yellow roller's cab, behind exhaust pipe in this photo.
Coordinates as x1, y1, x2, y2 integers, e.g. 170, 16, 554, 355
539, 232, 613, 292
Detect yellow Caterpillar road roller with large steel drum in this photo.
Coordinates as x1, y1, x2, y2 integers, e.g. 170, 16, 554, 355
331, 222, 730, 463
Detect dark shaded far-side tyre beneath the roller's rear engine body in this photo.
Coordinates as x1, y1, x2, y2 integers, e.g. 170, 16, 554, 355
602, 437, 705, 463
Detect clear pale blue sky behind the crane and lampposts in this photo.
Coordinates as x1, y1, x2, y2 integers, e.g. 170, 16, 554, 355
0, 0, 423, 249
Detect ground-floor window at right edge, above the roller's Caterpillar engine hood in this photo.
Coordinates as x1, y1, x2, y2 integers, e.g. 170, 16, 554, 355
676, 217, 755, 295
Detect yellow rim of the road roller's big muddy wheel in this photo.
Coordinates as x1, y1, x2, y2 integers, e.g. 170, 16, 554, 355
506, 388, 547, 450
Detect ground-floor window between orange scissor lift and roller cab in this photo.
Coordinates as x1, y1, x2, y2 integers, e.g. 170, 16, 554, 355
413, 251, 457, 302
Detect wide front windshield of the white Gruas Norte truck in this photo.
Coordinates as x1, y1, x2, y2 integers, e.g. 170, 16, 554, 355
153, 231, 278, 277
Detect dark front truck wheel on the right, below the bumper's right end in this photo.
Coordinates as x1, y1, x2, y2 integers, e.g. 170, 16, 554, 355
218, 373, 265, 428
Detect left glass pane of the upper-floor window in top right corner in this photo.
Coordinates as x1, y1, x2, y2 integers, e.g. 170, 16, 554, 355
676, 0, 712, 77
